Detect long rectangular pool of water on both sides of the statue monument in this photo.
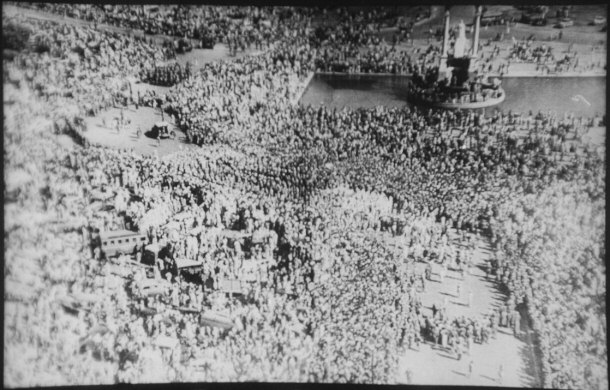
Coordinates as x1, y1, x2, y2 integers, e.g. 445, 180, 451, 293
300, 74, 606, 116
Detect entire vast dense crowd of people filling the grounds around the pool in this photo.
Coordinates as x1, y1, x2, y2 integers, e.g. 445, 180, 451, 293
3, 4, 607, 388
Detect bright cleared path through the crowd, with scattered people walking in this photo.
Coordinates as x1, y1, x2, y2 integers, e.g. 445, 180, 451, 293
399, 230, 541, 387
